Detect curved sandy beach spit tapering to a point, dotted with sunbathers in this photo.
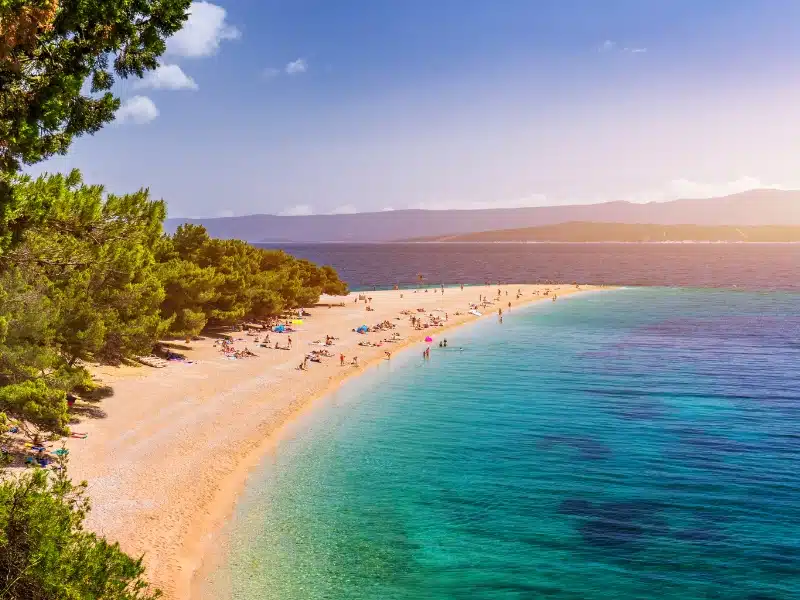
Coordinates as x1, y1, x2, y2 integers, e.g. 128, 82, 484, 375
61, 285, 596, 599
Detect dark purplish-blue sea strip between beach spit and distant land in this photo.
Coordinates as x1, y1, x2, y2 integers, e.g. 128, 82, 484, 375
260, 244, 800, 290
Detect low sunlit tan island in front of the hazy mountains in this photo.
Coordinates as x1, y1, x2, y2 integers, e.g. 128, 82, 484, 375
408, 221, 800, 243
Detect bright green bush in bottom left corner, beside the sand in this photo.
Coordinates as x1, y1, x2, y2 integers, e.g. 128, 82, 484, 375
0, 461, 161, 600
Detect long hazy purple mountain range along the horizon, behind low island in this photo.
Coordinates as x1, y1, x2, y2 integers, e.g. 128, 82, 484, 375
165, 190, 800, 243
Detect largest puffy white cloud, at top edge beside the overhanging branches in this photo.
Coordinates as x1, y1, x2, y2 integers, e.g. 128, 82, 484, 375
167, 2, 242, 58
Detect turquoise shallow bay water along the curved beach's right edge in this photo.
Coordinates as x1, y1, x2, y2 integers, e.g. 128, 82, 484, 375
203, 289, 800, 600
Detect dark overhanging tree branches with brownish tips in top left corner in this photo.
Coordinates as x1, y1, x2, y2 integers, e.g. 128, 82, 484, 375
0, 0, 190, 173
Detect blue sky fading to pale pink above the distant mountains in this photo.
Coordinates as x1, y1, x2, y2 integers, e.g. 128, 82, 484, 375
29, 0, 800, 217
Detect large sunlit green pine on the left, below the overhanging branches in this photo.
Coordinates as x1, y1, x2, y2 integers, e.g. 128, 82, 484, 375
0, 172, 168, 365
